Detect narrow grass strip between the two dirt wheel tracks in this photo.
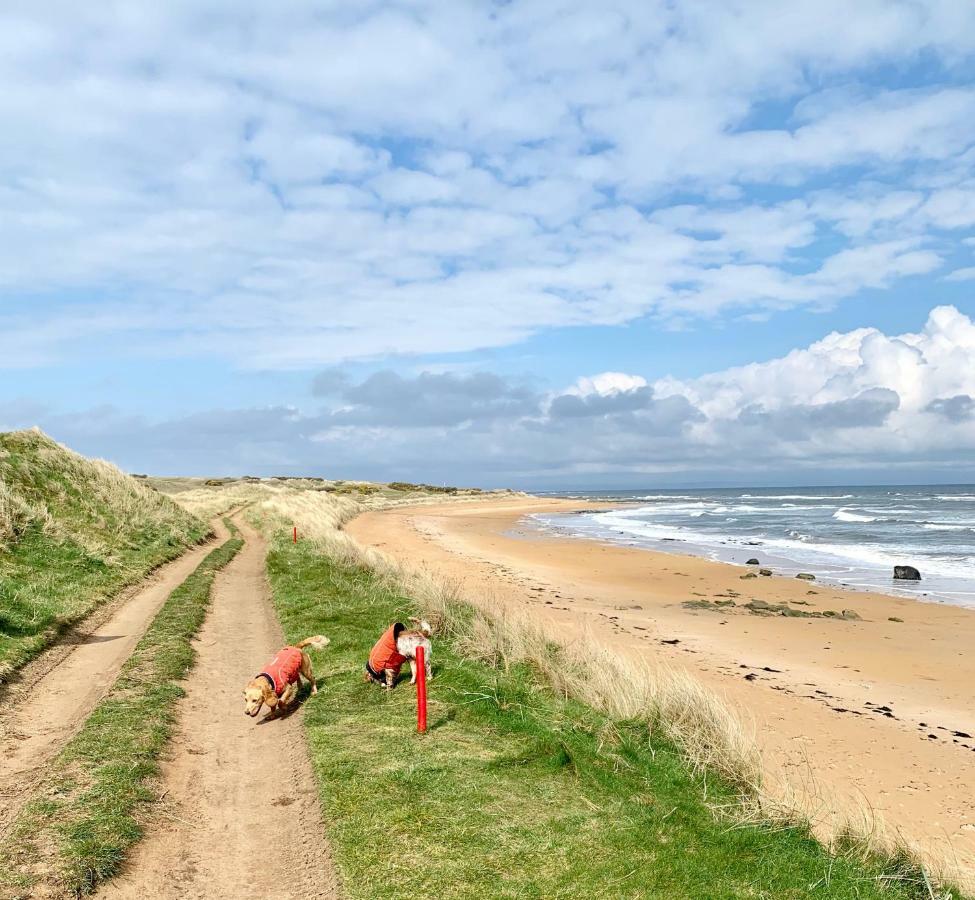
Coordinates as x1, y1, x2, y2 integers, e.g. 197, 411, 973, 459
0, 522, 243, 897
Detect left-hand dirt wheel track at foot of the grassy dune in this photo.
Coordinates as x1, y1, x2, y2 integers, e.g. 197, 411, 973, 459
0, 521, 228, 834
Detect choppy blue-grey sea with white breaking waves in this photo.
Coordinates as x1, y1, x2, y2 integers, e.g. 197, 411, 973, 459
532, 485, 975, 608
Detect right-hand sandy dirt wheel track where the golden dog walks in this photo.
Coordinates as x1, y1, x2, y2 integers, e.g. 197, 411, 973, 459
98, 519, 339, 900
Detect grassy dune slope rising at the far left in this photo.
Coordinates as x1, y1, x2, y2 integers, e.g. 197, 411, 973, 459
0, 431, 208, 681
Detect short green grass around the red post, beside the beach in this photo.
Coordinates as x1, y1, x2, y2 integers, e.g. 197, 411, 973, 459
268, 540, 958, 900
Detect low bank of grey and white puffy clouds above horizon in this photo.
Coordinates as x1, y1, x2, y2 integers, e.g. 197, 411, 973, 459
13, 306, 975, 487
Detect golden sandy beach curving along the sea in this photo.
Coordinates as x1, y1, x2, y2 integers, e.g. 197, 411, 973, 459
346, 497, 975, 890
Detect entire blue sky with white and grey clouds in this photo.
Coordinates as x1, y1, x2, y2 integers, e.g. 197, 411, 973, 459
0, 0, 975, 489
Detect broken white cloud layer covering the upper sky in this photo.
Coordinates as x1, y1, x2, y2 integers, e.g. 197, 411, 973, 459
0, 0, 975, 369
